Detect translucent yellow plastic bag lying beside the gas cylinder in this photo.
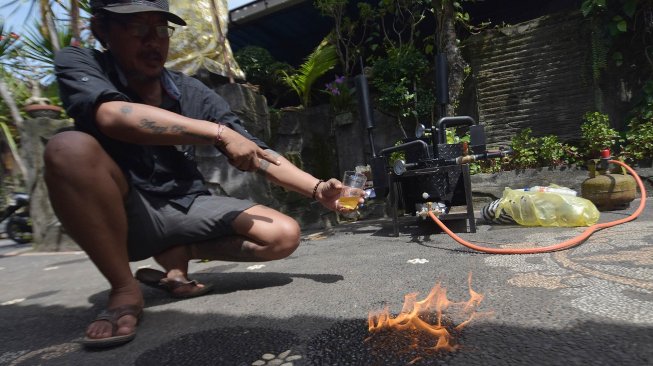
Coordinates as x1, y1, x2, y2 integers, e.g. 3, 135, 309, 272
495, 188, 600, 227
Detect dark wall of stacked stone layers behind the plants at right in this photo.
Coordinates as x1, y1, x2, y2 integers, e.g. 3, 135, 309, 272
462, 13, 596, 146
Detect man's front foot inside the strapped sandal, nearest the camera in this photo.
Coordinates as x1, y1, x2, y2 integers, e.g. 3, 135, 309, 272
86, 280, 144, 340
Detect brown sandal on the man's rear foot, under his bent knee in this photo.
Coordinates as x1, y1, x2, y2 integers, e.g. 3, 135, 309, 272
134, 268, 212, 299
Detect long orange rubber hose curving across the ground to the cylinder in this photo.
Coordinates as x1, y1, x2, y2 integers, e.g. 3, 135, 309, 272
429, 160, 646, 254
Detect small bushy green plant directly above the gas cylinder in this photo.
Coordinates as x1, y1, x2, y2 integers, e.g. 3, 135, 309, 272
580, 112, 621, 159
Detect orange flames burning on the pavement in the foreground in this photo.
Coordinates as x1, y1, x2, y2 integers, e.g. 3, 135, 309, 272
365, 273, 487, 363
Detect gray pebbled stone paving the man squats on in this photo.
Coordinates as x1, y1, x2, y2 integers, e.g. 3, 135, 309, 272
0, 202, 653, 366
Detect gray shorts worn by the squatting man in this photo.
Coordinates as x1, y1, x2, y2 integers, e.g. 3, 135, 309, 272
125, 187, 256, 261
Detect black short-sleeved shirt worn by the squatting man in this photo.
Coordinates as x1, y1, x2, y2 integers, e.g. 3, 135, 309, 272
55, 47, 268, 208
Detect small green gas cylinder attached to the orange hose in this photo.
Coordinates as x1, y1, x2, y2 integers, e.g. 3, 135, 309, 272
580, 159, 637, 211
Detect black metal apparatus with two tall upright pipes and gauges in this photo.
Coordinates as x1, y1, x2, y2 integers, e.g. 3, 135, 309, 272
354, 60, 504, 235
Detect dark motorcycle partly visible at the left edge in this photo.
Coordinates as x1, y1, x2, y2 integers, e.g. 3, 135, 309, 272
0, 192, 32, 244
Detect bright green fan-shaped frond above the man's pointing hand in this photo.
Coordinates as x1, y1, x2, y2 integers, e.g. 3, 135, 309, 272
282, 40, 338, 108
